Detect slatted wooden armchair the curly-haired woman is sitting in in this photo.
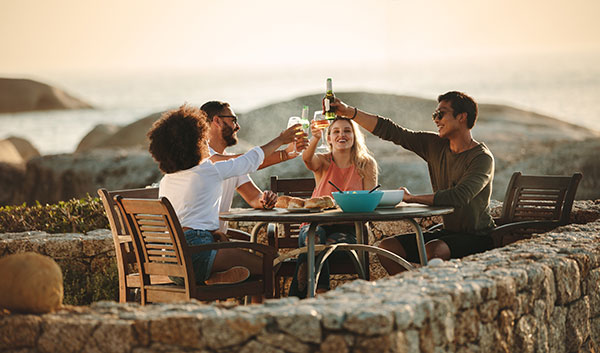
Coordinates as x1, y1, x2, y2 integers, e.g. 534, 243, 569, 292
115, 195, 277, 305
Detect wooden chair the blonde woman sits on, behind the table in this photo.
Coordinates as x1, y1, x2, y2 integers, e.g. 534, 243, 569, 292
267, 176, 369, 297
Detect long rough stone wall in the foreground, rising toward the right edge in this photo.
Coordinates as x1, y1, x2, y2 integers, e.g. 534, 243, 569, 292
0, 220, 600, 353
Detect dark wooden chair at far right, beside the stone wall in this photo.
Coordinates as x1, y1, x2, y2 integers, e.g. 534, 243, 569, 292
492, 172, 582, 247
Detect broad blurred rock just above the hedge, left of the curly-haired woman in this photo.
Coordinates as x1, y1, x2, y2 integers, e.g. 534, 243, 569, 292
12, 150, 161, 204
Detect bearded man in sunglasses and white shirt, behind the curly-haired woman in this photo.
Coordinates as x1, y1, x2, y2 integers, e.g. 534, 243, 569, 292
200, 101, 308, 233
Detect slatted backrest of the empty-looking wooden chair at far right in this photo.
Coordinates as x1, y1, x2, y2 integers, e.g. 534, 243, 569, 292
499, 172, 582, 225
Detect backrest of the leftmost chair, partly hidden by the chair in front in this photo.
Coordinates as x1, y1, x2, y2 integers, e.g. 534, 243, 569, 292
98, 188, 158, 303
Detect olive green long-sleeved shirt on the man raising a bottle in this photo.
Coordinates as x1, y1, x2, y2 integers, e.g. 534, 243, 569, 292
373, 117, 495, 234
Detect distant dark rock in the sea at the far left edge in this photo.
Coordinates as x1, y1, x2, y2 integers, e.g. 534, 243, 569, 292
0, 78, 92, 113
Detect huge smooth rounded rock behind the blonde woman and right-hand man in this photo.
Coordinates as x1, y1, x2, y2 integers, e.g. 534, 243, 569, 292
233, 92, 600, 200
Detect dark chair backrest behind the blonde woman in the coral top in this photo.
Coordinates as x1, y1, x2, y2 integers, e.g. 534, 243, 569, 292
268, 175, 316, 249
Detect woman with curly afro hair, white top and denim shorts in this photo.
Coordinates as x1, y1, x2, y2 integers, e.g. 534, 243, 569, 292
148, 105, 301, 284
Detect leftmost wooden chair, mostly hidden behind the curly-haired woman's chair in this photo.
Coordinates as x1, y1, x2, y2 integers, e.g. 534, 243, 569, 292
98, 188, 250, 303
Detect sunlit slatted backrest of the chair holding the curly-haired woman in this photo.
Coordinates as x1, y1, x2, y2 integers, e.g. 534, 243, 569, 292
115, 195, 196, 302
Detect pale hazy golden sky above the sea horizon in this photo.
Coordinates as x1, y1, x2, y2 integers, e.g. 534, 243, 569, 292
0, 0, 600, 74
